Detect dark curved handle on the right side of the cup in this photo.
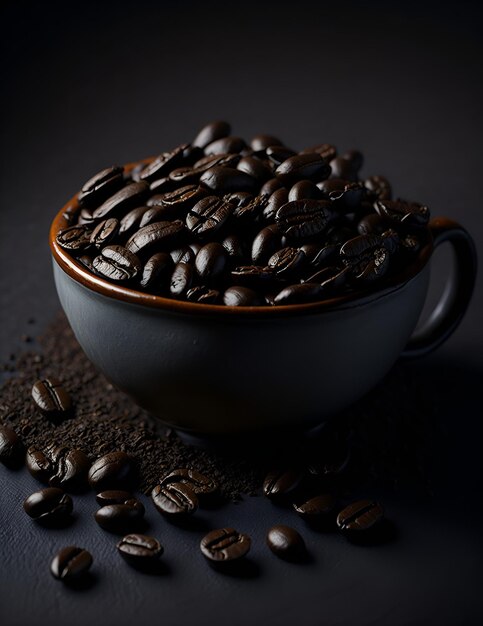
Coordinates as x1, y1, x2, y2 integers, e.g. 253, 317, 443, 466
401, 217, 477, 358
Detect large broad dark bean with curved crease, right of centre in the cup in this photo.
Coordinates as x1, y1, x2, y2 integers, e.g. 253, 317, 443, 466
275, 200, 333, 241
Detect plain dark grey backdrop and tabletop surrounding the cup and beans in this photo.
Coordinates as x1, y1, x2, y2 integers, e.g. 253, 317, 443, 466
0, 1, 483, 626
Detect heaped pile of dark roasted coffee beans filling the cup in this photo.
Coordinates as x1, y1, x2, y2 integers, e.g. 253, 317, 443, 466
56, 122, 429, 304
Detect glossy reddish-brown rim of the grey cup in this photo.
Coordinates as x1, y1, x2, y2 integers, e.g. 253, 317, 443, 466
49, 157, 433, 318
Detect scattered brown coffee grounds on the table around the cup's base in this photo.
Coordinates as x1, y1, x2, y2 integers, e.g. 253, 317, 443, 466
0, 313, 436, 500
